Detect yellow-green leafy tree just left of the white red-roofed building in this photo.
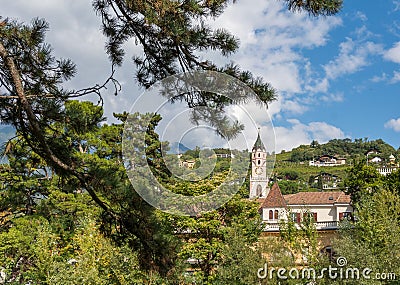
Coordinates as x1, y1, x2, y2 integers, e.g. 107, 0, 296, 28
176, 193, 261, 284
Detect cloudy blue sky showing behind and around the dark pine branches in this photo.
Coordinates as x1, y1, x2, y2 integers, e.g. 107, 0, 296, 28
0, 0, 400, 152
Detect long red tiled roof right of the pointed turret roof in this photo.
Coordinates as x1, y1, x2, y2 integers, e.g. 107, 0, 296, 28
284, 191, 350, 205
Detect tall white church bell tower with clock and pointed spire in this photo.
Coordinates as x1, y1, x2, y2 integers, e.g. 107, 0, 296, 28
249, 129, 269, 199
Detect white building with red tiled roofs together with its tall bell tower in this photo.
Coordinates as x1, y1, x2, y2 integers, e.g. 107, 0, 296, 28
249, 134, 353, 232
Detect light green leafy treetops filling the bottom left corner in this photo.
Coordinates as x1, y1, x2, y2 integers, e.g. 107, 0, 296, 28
0, 216, 158, 285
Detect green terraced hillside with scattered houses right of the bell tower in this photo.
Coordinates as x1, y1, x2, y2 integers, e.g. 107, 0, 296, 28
273, 139, 400, 194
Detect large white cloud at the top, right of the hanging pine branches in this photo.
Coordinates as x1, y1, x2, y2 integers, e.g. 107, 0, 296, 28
209, 0, 342, 96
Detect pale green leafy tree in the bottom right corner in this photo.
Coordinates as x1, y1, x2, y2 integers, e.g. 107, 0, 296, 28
334, 188, 400, 284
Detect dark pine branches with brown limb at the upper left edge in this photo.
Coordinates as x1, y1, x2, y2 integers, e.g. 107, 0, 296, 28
0, 19, 75, 171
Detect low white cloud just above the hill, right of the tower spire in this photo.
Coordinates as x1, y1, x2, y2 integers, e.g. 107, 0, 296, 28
275, 119, 346, 152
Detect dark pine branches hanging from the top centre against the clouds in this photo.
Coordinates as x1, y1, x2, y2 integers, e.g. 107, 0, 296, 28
93, 0, 275, 106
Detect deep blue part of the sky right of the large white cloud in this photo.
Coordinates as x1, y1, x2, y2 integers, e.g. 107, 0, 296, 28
298, 0, 400, 147
